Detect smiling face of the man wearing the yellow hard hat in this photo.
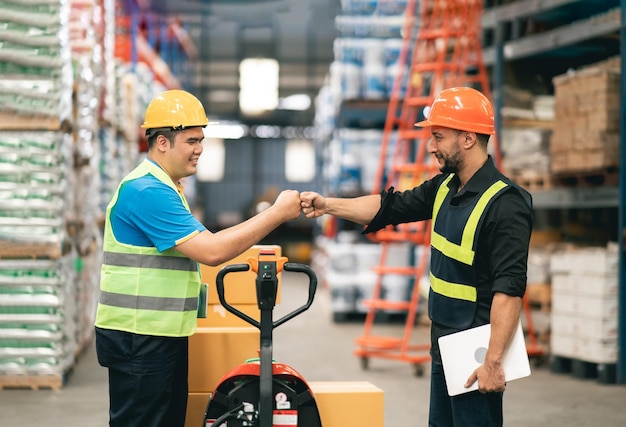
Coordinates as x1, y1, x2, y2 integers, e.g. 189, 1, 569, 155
155, 127, 204, 182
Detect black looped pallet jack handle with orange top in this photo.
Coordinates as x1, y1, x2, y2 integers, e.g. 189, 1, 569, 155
215, 250, 317, 329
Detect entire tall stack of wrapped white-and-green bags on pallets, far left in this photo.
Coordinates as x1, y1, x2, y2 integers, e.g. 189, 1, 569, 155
0, 0, 119, 389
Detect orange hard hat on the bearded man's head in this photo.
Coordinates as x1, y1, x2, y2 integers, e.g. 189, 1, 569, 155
415, 87, 495, 135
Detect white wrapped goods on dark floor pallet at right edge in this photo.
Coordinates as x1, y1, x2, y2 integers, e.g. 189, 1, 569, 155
550, 243, 619, 383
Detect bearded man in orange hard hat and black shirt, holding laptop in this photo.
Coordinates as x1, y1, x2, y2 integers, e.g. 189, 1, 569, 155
300, 87, 533, 427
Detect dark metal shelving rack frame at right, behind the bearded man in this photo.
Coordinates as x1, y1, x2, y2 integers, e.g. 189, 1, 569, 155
482, 0, 626, 383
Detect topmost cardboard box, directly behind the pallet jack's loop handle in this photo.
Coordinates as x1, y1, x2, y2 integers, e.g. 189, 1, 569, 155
200, 245, 281, 306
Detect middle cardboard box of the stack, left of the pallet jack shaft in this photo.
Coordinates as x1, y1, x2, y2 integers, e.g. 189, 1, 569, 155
189, 326, 260, 393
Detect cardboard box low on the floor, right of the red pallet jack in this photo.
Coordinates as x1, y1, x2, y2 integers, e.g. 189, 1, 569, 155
308, 381, 385, 427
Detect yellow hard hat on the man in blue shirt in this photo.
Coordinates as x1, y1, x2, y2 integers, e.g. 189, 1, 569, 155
141, 90, 209, 130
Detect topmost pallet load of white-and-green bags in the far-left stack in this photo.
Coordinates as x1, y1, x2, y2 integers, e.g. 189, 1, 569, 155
0, 0, 72, 127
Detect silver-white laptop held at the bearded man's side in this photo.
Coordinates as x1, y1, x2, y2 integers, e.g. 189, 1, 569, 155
439, 320, 530, 396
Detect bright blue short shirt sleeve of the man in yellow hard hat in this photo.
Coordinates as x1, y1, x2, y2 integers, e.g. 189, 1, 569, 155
111, 175, 206, 252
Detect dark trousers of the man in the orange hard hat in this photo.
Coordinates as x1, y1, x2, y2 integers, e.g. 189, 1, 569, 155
428, 362, 503, 427
